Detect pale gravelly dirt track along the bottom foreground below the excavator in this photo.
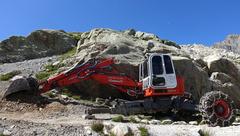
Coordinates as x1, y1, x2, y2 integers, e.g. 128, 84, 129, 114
0, 109, 240, 136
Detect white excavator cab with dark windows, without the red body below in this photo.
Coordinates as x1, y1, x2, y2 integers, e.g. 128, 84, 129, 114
139, 54, 177, 89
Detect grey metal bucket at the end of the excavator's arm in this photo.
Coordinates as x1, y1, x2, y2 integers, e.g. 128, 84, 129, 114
0, 76, 38, 99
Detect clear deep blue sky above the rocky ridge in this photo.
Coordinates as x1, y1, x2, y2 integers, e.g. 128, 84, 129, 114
0, 0, 240, 45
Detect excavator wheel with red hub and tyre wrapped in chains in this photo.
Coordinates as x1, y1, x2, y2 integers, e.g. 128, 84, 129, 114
199, 91, 236, 127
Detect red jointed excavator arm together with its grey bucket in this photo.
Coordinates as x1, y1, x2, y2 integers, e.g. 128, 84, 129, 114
2, 58, 142, 98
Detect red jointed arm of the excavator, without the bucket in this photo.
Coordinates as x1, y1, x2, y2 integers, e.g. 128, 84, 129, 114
39, 58, 142, 96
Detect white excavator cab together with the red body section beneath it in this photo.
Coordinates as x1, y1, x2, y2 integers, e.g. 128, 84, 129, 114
139, 53, 183, 96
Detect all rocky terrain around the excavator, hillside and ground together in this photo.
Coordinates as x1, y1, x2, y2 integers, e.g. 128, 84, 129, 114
0, 28, 240, 136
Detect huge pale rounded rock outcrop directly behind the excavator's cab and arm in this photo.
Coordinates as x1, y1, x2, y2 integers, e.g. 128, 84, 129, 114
65, 29, 210, 101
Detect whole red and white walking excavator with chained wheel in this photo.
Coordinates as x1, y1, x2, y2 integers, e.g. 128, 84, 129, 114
4, 53, 235, 126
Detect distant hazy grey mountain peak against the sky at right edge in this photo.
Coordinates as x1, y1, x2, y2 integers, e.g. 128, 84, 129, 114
214, 34, 240, 53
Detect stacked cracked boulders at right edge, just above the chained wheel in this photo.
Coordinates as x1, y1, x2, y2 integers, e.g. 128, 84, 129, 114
205, 55, 240, 106
